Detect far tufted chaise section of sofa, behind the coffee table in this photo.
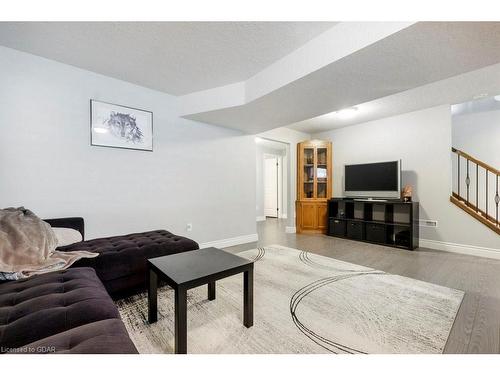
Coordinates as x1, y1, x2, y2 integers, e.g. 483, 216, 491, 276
58, 230, 199, 284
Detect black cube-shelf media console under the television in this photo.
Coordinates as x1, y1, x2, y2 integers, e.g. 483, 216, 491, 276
327, 198, 419, 250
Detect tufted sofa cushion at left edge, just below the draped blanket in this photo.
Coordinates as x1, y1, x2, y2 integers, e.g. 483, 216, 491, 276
0, 268, 120, 350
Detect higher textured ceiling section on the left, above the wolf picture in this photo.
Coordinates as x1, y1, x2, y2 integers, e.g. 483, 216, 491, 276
0, 22, 335, 95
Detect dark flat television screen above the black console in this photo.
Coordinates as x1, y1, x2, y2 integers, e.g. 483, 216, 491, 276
344, 161, 400, 192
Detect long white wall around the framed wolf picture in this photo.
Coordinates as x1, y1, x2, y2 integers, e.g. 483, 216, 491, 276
0, 48, 256, 242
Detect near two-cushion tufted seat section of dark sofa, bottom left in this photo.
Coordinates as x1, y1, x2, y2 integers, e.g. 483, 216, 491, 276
0, 268, 137, 354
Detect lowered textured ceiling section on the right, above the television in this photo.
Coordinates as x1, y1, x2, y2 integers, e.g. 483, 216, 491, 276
185, 22, 500, 133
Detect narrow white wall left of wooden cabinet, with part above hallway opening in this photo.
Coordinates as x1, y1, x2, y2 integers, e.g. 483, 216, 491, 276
258, 127, 311, 232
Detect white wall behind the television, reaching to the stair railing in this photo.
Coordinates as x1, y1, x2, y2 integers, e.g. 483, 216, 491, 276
315, 105, 500, 257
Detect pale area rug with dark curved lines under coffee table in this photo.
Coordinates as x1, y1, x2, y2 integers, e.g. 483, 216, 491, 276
116, 245, 464, 354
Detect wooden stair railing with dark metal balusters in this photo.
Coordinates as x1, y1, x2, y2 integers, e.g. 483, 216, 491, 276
451, 147, 500, 227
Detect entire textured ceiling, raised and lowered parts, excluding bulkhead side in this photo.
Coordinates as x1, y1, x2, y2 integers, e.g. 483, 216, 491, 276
0, 22, 500, 133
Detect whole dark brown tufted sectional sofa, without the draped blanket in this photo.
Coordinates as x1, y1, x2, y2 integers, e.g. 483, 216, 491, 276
0, 218, 198, 353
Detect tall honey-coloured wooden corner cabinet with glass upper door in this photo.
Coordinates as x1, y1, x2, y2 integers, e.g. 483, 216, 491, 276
295, 140, 333, 233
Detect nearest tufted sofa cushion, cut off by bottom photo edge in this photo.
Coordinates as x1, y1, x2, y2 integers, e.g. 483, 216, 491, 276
14, 319, 137, 354
